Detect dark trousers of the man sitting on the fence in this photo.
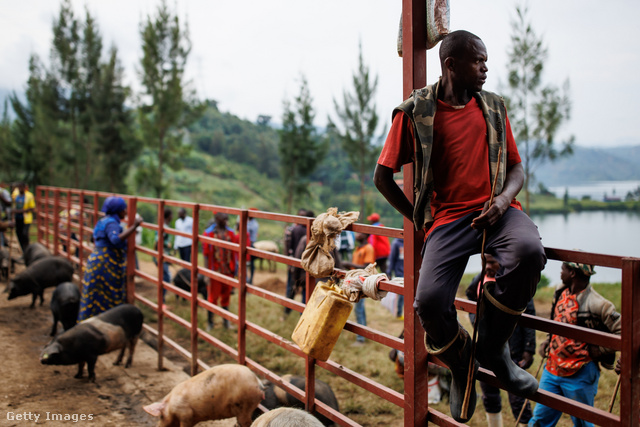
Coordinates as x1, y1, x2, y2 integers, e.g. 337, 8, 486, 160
413, 207, 547, 347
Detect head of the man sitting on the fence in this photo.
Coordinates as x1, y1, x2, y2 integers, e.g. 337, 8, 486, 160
440, 30, 488, 92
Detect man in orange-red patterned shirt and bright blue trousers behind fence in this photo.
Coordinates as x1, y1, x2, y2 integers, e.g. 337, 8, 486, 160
529, 262, 622, 427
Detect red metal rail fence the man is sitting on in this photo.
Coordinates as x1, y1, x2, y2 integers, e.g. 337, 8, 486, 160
36, 186, 640, 426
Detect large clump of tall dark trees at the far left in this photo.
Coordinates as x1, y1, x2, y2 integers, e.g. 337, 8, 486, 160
3, 0, 137, 191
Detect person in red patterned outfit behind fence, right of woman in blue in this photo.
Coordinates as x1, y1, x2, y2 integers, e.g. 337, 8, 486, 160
202, 212, 238, 330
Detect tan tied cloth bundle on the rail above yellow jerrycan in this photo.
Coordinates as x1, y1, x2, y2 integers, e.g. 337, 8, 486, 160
301, 208, 360, 277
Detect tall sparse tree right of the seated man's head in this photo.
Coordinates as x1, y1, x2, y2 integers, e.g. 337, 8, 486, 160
507, 1, 573, 212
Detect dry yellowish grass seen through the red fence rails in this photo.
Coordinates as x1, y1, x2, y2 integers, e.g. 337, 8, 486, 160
134, 264, 620, 427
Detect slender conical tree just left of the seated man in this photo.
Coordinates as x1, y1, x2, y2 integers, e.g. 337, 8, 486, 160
329, 45, 384, 212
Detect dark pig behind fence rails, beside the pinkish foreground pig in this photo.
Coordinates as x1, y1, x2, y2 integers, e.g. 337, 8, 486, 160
253, 375, 340, 426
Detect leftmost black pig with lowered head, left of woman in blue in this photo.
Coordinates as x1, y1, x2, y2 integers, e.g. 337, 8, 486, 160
8, 256, 73, 308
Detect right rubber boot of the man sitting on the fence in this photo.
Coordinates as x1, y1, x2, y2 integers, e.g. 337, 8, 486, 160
476, 282, 538, 397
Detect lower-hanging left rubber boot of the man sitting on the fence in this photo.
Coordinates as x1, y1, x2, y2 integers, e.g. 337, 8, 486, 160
425, 325, 478, 423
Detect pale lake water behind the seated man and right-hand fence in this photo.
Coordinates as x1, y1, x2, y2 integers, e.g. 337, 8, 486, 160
465, 211, 640, 285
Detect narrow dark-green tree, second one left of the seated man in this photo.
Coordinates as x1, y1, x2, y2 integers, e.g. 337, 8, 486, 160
279, 76, 327, 212
